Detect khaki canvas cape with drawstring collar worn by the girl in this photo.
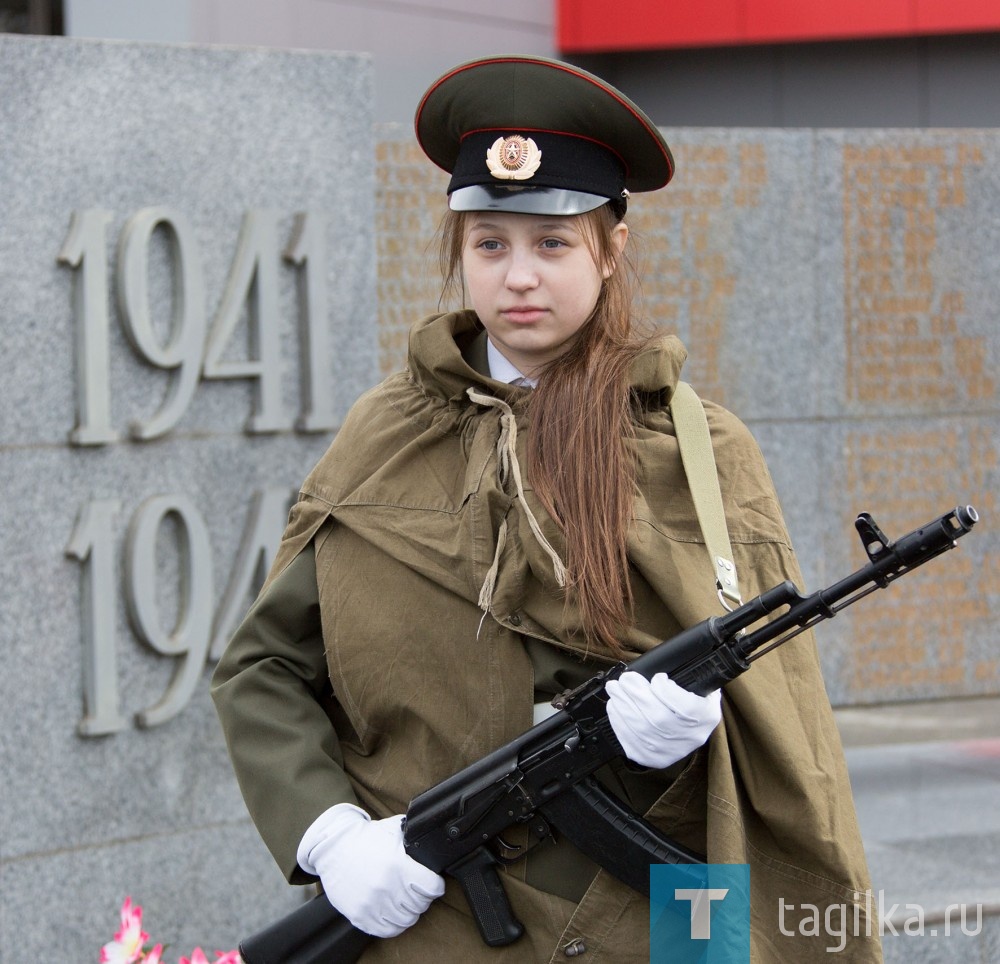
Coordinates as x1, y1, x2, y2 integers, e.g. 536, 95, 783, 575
216, 312, 881, 964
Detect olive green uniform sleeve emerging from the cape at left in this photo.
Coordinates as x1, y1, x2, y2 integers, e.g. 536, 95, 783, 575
212, 543, 357, 883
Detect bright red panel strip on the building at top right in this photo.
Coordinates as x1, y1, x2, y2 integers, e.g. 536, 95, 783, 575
556, 0, 1000, 53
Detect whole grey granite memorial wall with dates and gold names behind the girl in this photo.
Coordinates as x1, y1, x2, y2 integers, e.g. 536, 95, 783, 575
0, 37, 1000, 964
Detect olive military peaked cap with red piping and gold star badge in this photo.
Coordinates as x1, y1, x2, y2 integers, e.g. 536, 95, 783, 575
415, 56, 674, 214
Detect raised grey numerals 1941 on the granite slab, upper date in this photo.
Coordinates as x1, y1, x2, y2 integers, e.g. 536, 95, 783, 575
59, 207, 335, 445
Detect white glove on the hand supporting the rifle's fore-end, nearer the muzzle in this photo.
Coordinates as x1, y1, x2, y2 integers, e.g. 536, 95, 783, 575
605, 672, 722, 770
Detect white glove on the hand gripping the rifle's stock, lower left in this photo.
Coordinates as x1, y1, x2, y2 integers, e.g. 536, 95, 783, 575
296, 803, 444, 937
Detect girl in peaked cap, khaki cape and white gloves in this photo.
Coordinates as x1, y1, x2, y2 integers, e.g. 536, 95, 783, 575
213, 57, 881, 964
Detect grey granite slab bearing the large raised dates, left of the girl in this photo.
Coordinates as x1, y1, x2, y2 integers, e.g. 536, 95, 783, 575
0, 37, 378, 964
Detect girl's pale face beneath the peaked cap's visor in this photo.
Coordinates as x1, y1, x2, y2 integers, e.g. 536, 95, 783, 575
462, 211, 628, 377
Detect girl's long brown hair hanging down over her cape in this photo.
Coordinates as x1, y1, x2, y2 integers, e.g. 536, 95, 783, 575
440, 204, 647, 656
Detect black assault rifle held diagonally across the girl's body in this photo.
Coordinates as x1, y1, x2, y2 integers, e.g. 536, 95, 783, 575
240, 506, 979, 964
